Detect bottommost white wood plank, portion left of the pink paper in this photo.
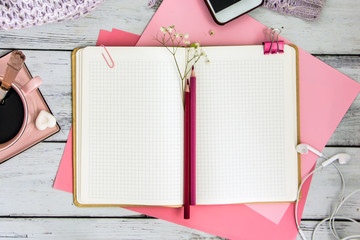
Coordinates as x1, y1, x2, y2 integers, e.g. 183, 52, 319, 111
0, 218, 221, 240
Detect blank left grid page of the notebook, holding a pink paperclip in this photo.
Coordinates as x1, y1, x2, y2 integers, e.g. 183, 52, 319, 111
76, 47, 184, 205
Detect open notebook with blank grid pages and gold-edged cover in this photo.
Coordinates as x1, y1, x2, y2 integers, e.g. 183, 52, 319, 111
73, 45, 299, 206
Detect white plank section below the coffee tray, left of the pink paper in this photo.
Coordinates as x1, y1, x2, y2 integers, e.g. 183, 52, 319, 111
0, 143, 140, 218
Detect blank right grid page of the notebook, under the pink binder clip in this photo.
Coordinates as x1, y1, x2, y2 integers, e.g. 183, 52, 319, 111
196, 46, 298, 204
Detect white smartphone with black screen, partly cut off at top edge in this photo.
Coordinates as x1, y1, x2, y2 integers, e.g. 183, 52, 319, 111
205, 0, 263, 25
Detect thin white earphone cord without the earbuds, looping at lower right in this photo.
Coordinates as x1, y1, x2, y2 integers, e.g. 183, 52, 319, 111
295, 158, 360, 240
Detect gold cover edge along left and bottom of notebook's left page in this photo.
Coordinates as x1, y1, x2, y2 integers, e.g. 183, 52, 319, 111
71, 48, 183, 208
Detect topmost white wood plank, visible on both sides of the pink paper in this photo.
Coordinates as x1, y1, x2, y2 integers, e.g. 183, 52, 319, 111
0, 0, 360, 54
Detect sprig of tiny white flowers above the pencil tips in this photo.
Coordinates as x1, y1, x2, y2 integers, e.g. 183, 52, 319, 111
156, 25, 208, 105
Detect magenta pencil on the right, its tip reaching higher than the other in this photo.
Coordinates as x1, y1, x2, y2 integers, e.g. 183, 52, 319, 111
190, 66, 196, 205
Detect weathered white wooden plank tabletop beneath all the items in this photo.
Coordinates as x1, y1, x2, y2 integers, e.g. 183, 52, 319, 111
0, 0, 360, 239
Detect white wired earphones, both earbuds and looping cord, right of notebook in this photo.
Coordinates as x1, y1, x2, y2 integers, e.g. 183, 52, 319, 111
295, 143, 360, 240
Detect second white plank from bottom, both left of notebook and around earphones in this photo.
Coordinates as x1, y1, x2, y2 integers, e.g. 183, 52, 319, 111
0, 143, 360, 219
